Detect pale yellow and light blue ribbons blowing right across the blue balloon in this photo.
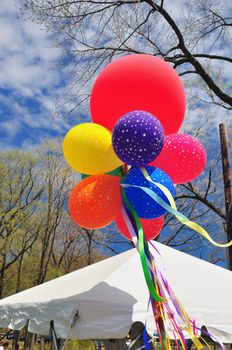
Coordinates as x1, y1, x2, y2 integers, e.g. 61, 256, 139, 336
121, 167, 232, 248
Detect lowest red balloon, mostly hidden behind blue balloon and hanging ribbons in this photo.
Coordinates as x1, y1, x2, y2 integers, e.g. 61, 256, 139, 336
115, 212, 164, 241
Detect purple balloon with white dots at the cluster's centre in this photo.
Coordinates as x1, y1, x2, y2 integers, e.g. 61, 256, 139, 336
112, 111, 164, 166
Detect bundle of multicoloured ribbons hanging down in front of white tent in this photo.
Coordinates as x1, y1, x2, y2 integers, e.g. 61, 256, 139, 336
119, 183, 203, 350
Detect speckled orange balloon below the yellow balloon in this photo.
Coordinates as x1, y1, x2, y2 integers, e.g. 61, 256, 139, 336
68, 174, 121, 229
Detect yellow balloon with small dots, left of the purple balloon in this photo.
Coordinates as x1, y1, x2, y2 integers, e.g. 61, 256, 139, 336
63, 123, 123, 175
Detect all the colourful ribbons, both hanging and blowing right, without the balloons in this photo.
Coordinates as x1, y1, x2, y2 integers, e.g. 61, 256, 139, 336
121, 168, 229, 350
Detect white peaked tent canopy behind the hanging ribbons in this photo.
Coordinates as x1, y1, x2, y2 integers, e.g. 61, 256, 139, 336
0, 243, 232, 342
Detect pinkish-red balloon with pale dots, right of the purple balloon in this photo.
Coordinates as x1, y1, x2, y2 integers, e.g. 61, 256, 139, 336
150, 134, 207, 184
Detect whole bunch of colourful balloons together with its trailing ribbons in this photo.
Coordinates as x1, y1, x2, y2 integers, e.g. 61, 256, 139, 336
63, 55, 232, 350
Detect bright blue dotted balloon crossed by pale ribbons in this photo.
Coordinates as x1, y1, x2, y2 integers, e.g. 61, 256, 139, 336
124, 166, 175, 219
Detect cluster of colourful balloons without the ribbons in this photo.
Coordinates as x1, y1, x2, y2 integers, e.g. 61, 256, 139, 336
63, 55, 206, 240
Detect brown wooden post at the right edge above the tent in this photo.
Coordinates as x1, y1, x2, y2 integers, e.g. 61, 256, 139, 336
219, 124, 232, 271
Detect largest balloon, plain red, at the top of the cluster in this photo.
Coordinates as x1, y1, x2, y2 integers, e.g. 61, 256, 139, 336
90, 54, 186, 134
